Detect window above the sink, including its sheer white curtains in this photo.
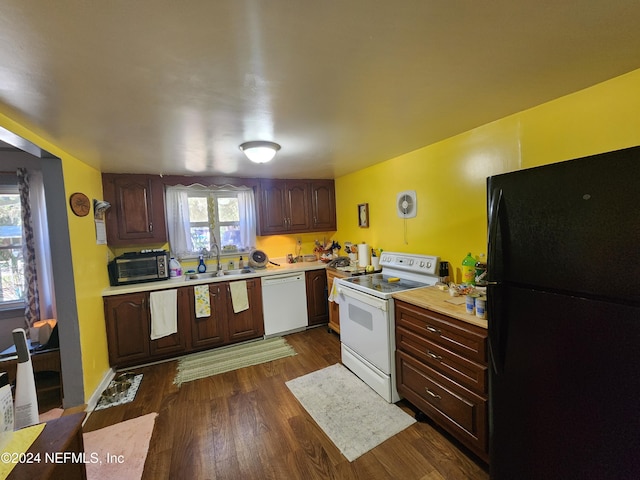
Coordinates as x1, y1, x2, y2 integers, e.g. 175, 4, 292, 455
166, 186, 256, 258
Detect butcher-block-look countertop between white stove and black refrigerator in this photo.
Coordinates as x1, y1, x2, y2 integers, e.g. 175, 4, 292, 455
393, 287, 488, 328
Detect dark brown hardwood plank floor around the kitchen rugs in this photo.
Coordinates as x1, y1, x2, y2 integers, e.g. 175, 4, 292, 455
84, 328, 489, 480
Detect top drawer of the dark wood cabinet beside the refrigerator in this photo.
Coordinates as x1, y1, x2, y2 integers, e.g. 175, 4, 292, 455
396, 302, 487, 364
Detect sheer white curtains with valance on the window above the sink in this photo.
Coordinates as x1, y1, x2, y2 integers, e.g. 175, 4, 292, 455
165, 185, 256, 257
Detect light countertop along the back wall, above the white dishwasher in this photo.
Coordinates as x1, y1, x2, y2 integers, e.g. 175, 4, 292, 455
102, 259, 326, 297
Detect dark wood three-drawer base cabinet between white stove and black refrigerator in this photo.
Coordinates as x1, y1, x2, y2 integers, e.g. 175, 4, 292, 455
395, 301, 489, 463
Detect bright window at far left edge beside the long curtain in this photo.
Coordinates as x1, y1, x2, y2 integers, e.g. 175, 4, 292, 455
0, 184, 25, 310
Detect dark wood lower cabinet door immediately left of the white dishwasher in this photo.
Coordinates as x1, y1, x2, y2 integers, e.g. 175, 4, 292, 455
226, 278, 264, 343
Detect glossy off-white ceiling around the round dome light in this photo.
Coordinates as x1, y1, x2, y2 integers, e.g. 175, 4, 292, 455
0, 0, 640, 178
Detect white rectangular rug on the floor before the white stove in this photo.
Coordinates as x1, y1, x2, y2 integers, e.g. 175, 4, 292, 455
286, 364, 415, 462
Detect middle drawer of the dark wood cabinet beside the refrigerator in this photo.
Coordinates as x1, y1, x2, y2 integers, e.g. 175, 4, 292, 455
396, 327, 487, 395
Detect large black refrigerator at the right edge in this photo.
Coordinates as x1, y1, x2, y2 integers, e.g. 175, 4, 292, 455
487, 147, 640, 480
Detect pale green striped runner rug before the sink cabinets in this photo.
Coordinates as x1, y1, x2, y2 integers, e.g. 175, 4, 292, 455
173, 337, 296, 385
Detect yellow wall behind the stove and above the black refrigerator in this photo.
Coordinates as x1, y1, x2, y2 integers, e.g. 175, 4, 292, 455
335, 70, 640, 281
